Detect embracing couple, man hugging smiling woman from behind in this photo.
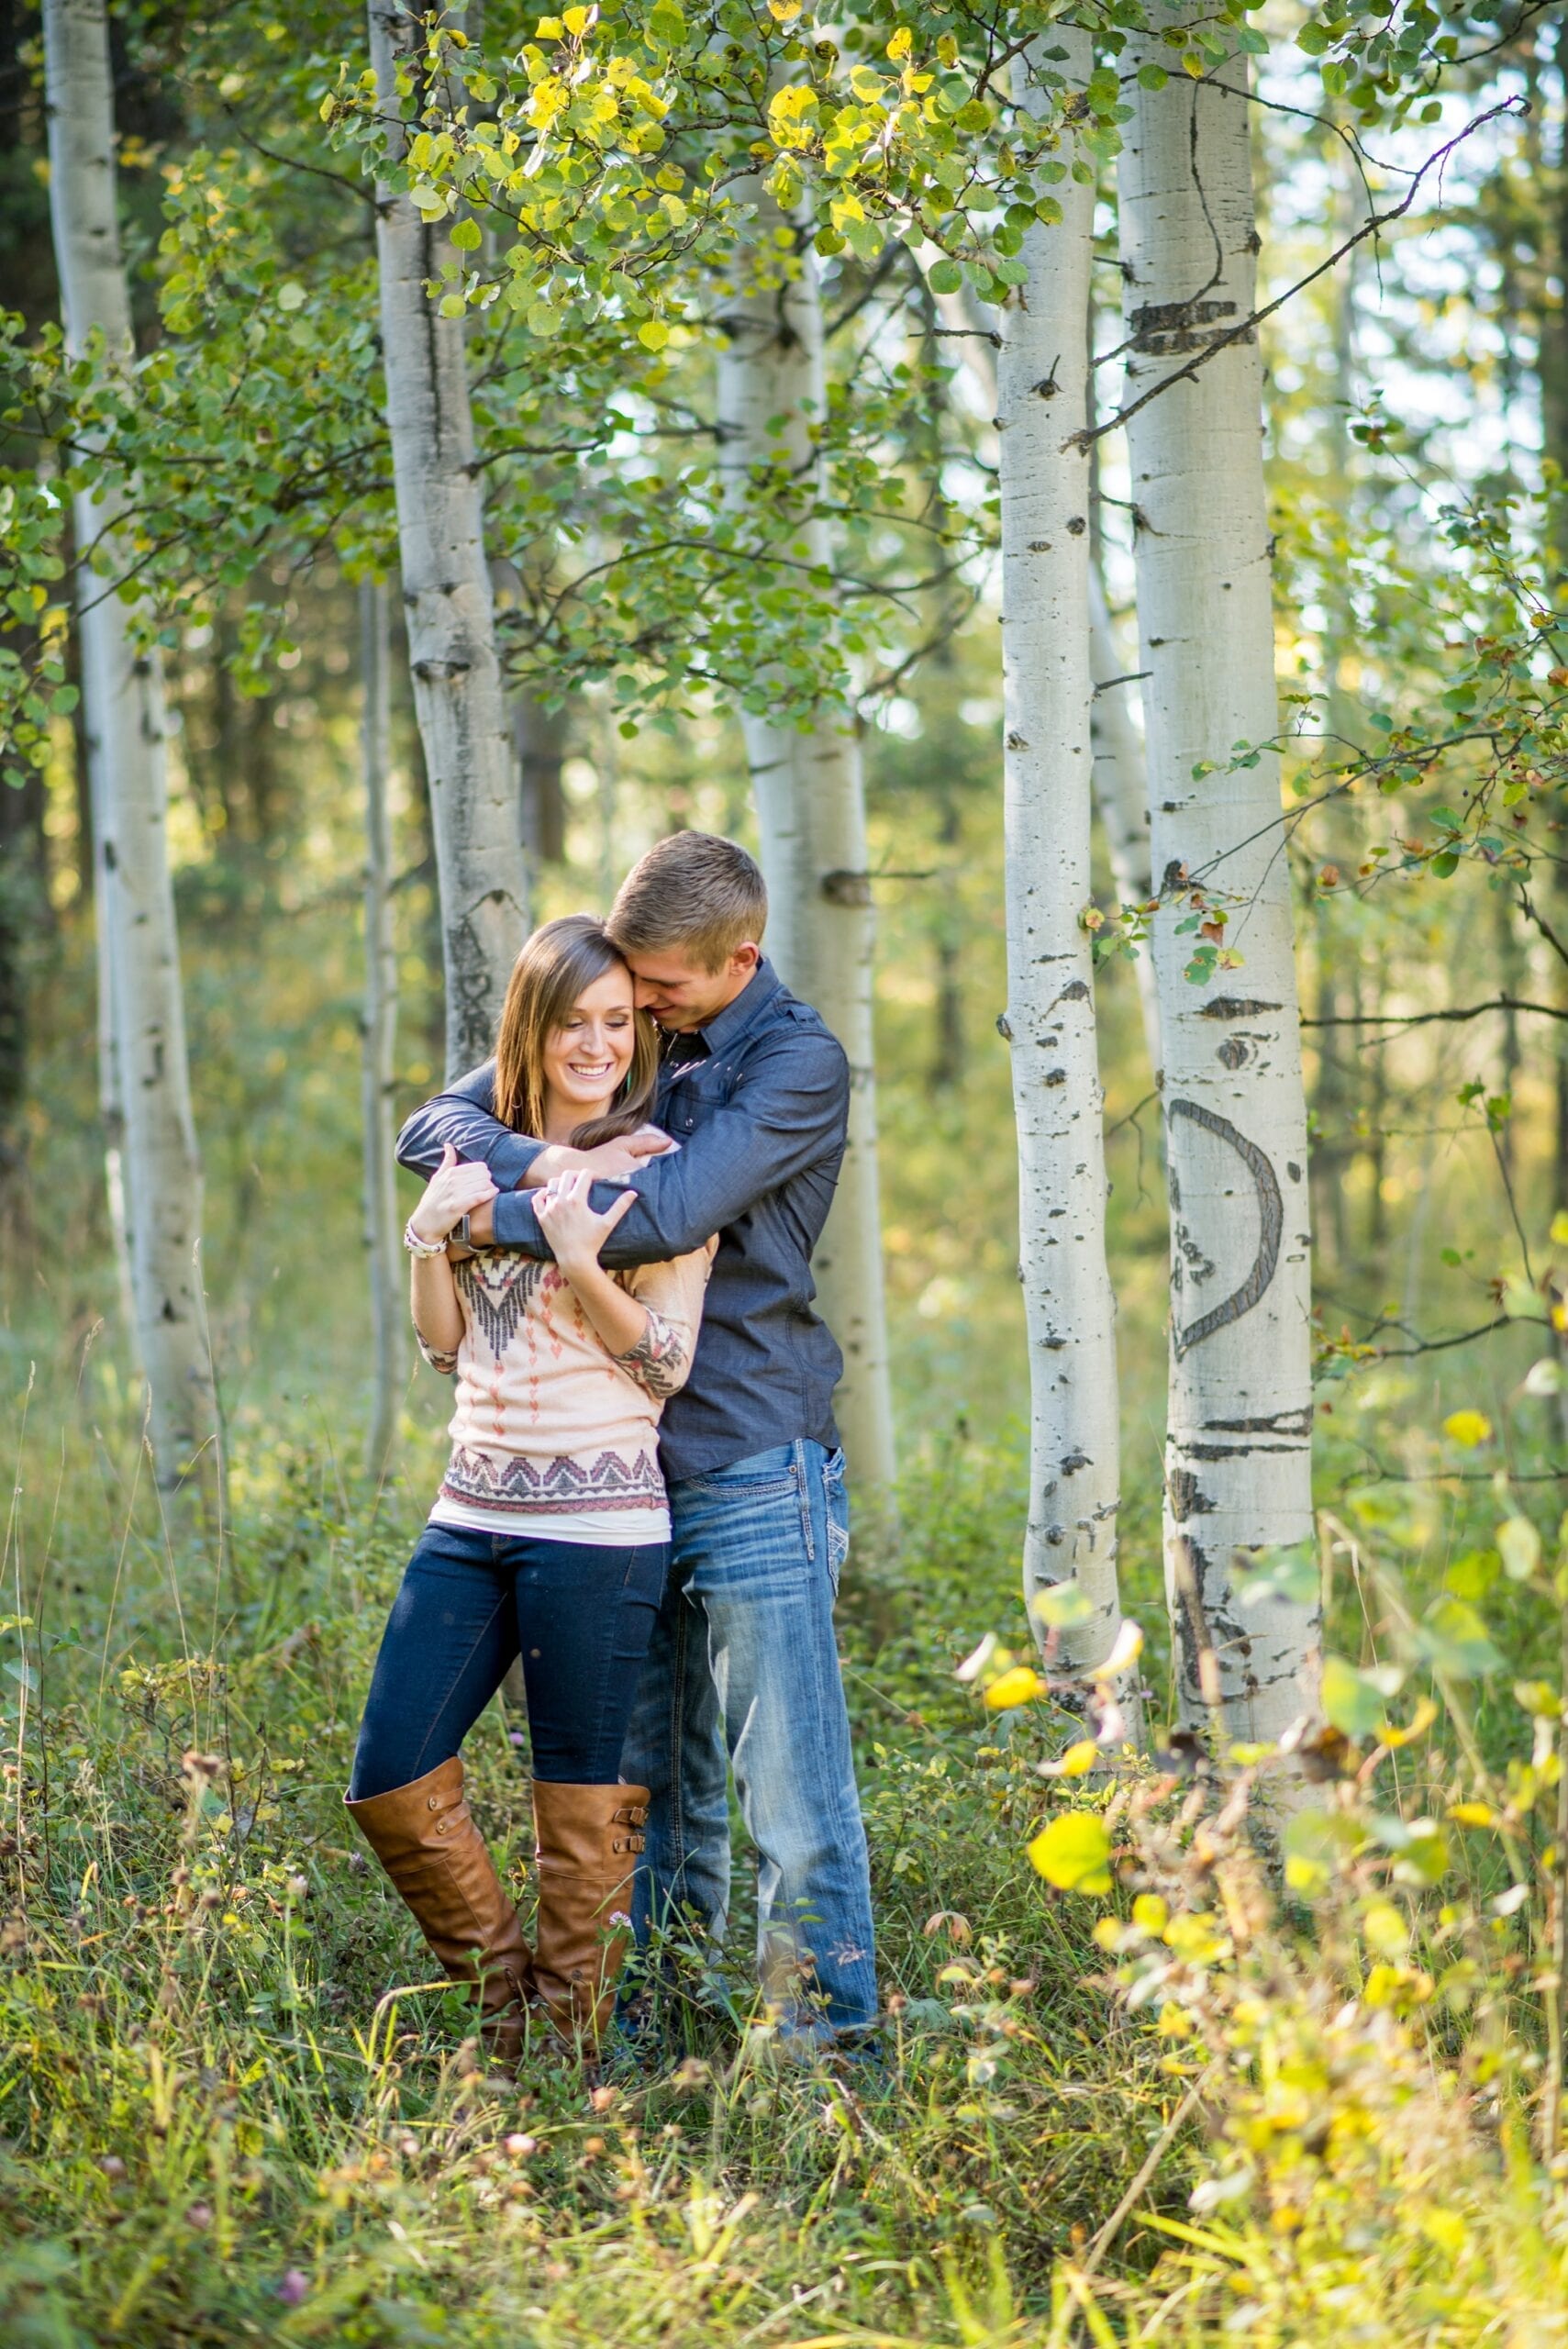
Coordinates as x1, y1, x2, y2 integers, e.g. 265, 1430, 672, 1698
348, 831, 875, 2060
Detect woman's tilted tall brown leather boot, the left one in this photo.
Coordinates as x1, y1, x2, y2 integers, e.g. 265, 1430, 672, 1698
343, 1757, 533, 2063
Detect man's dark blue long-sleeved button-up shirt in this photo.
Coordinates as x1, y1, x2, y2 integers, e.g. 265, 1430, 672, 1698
396, 958, 850, 1485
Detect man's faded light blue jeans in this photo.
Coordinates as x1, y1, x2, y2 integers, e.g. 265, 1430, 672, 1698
622, 1440, 875, 2032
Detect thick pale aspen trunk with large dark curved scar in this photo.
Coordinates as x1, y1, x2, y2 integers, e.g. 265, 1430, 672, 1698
1119, 28, 1319, 1738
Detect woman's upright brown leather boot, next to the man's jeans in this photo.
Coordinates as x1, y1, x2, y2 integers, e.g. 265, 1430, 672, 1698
533, 1778, 648, 2042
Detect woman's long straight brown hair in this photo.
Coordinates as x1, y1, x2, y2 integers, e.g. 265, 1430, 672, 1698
495, 914, 660, 1151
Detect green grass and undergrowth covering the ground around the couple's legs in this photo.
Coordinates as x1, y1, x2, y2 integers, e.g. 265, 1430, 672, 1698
0, 1386, 1568, 2349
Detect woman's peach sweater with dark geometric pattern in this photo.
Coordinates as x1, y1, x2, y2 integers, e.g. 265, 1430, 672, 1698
416, 1245, 714, 1541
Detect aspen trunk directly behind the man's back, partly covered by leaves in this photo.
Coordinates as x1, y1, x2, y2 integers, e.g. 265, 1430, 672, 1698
718, 181, 895, 1486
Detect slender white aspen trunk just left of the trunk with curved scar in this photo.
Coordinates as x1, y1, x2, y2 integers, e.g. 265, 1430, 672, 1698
997, 26, 1122, 1670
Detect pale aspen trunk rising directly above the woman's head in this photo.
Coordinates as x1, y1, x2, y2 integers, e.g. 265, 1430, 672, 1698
369, 0, 528, 1078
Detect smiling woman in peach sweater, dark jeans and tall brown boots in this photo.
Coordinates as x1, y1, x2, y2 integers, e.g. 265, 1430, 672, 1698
350, 914, 711, 2058
